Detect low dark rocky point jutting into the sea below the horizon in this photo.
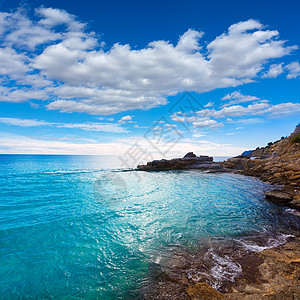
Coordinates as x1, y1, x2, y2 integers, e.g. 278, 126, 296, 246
137, 152, 226, 172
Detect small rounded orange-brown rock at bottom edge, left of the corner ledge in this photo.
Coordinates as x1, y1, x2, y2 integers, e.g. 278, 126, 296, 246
185, 282, 228, 300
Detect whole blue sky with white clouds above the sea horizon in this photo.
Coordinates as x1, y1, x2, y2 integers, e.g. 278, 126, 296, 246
0, 0, 300, 164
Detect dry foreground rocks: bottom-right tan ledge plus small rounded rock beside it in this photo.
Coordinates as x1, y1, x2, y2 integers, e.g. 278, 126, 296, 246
186, 238, 300, 300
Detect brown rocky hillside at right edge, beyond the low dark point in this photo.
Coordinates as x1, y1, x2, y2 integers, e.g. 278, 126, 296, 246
222, 126, 300, 209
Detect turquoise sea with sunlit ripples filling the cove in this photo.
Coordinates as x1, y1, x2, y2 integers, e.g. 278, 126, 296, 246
0, 155, 299, 299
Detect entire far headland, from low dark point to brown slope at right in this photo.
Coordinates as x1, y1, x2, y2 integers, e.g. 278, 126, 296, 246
137, 125, 300, 210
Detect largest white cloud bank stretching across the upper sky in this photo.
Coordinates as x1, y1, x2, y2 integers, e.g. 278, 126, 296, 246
0, 7, 297, 115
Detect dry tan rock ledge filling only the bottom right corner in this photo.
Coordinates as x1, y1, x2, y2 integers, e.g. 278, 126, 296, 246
226, 238, 300, 300
